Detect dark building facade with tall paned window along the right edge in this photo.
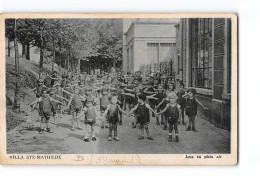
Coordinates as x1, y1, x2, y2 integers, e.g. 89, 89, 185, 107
174, 18, 232, 129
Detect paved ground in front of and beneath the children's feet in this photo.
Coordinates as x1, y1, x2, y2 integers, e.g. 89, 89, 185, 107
7, 103, 230, 154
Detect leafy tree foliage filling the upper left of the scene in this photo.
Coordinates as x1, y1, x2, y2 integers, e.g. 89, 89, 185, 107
5, 18, 122, 69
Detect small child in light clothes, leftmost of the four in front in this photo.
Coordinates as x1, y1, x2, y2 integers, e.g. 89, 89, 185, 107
76, 99, 101, 142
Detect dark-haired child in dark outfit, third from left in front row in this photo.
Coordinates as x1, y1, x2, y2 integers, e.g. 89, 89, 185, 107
128, 94, 155, 140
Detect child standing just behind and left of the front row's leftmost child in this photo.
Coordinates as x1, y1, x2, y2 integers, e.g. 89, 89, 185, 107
67, 88, 83, 131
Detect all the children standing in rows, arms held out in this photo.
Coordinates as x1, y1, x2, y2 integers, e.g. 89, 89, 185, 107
31, 70, 197, 142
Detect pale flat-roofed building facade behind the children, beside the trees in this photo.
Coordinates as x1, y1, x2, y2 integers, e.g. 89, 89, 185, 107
123, 18, 179, 72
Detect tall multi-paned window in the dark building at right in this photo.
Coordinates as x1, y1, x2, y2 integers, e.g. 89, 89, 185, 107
191, 18, 212, 89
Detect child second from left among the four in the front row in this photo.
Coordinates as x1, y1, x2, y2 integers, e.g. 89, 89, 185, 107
103, 94, 126, 141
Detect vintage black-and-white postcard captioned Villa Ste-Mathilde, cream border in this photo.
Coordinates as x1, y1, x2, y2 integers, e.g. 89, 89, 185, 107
0, 13, 238, 165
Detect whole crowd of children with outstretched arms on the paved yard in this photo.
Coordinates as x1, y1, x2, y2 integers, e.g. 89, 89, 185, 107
30, 69, 197, 142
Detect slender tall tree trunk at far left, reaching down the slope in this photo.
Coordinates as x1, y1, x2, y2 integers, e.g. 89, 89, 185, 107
13, 20, 20, 112
